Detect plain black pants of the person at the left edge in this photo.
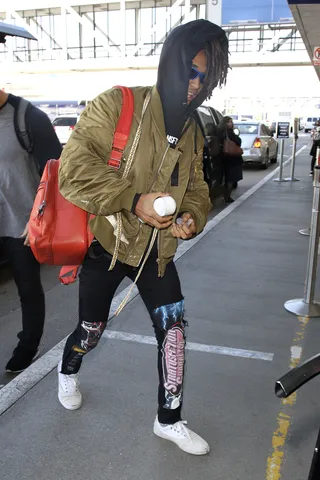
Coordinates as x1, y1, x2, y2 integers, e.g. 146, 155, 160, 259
0, 237, 45, 351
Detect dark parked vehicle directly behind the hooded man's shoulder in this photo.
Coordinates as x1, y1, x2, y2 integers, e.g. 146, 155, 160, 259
195, 105, 223, 198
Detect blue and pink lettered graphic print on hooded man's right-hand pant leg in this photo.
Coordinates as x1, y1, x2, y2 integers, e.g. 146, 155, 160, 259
152, 300, 186, 410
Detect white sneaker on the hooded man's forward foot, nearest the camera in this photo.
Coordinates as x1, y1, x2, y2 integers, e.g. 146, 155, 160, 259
153, 417, 210, 455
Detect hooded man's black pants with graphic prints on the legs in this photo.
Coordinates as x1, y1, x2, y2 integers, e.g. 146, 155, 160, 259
61, 242, 185, 424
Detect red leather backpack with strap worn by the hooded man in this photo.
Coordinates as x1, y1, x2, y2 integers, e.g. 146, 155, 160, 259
29, 86, 134, 284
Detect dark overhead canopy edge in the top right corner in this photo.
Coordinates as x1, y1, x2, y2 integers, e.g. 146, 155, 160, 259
288, 0, 320, 79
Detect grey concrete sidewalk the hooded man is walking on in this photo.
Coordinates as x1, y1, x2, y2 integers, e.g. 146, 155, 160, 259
0, 150, 320, 480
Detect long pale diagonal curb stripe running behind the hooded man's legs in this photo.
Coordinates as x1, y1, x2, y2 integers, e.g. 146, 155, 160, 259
0, 145, 307, 415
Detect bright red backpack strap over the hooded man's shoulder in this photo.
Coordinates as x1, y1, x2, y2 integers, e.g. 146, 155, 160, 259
108, 85, 134, 170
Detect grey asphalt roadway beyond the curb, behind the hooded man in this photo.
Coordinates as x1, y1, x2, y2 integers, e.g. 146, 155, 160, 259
0, 134, 310, 385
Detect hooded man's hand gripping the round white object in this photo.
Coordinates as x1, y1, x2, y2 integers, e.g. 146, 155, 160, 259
134, 192, 173, 230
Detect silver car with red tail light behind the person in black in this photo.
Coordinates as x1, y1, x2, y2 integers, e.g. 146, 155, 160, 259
234, 121, 278, 168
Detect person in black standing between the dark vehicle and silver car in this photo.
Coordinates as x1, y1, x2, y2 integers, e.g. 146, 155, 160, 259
219, 117, 243, 203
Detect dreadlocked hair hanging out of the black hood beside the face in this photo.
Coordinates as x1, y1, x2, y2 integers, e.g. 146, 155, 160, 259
204, 36, 230, 98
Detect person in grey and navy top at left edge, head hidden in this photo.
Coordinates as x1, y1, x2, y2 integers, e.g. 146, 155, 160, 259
0, 90, 62, 373
